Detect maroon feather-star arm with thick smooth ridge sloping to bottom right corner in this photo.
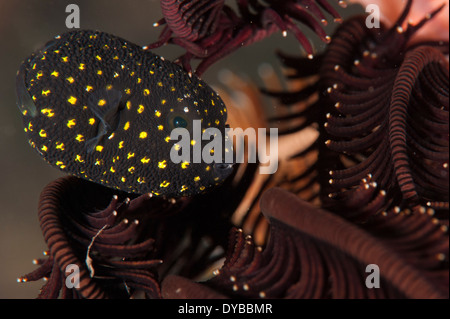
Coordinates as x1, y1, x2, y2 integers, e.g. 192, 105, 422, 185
162, 188, 448, 298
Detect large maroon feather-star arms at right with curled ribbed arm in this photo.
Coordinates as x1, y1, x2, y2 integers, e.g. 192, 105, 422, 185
269, 1, 449, 221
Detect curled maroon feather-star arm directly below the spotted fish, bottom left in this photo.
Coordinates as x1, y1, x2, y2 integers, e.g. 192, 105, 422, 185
18, 177, 183, 298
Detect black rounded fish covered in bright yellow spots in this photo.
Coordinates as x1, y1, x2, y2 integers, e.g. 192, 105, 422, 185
16, 31, 236, 197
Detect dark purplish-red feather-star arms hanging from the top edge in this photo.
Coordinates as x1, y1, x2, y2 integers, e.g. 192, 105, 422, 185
148, 0, 342, 75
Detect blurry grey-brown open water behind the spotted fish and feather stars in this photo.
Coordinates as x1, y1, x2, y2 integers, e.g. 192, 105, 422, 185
0, 0, 362, 298
